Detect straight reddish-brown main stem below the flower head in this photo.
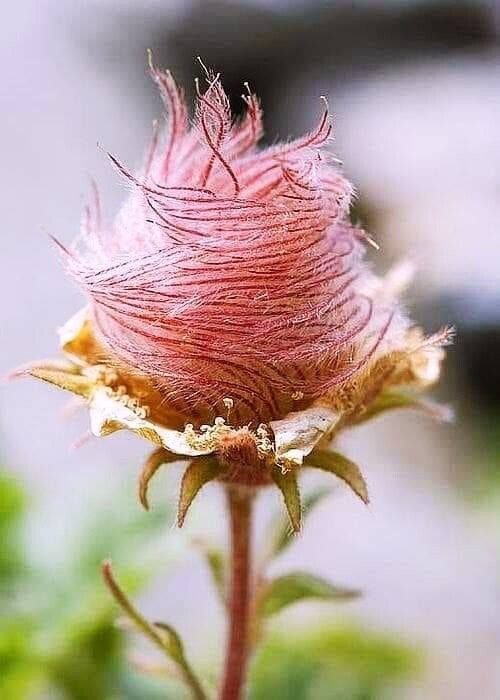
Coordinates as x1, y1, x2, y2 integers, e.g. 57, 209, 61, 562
219, 486, 253, 700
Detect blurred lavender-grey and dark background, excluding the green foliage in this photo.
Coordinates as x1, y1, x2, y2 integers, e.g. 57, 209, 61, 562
0, 0, 500, 700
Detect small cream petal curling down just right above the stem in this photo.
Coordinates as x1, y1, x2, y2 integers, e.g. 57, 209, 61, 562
269, 406, 340, 466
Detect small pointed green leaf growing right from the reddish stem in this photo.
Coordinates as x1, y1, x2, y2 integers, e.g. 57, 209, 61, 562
260, 571, 360, 617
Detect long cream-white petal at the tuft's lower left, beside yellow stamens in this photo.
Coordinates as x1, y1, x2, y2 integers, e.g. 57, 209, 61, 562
89, 387, 213, 457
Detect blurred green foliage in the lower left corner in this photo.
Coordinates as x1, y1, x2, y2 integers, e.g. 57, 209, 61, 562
0, 473, 183, 700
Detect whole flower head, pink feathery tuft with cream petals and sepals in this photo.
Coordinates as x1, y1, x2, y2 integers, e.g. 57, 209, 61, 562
21, 61, 449, 527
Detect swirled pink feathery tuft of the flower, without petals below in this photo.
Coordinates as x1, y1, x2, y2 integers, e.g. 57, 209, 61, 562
65, 60, 406, 425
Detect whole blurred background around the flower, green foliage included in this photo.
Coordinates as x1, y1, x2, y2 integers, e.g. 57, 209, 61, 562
0, 0, 500, 700
